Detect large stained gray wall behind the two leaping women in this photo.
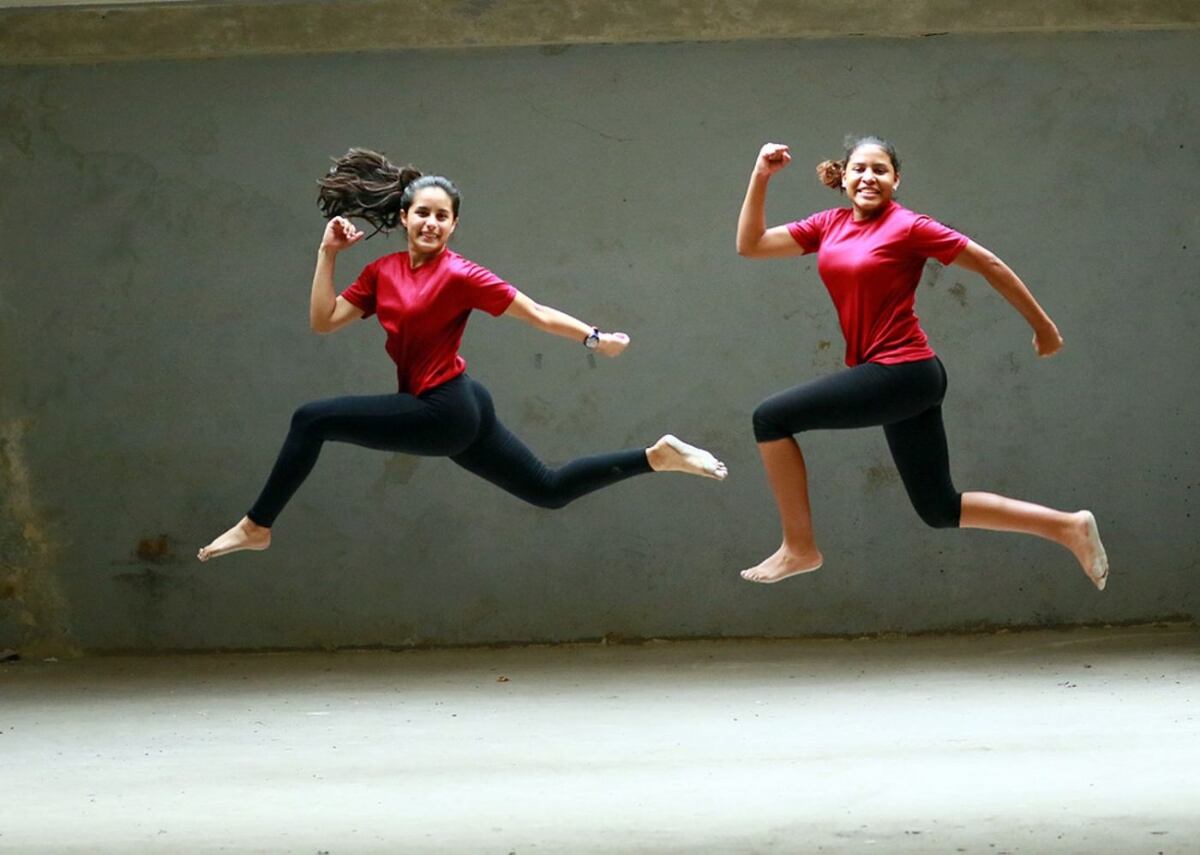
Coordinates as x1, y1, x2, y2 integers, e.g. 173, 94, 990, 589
0, 31, 1200, 652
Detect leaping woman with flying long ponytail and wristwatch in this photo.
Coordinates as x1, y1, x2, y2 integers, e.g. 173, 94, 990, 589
198, 149, 726, 561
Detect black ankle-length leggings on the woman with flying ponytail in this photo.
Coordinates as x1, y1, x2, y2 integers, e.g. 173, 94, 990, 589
247, 375, 650, 527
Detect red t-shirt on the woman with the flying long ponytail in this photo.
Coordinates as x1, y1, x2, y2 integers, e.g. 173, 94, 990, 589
342, 250, 517, 395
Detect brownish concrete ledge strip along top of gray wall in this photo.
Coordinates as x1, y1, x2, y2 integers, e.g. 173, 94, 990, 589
0, 0, 1200, 65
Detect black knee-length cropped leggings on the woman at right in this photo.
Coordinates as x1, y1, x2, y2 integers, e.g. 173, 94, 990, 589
754, 357, 962, 528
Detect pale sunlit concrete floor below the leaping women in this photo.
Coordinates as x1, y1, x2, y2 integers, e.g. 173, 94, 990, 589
0, 626, 1200, 855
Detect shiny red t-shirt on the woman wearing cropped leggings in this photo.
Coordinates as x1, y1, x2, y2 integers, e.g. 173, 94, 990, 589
787, 202, 968, 365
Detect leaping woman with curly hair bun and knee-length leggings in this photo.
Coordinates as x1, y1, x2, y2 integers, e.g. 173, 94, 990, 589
737, 137, 1109, 590
